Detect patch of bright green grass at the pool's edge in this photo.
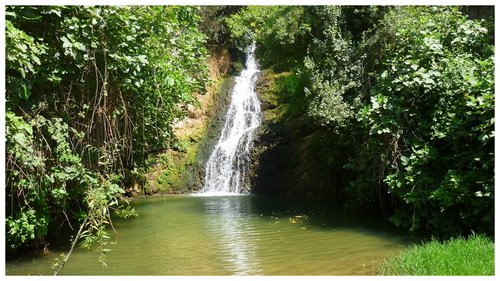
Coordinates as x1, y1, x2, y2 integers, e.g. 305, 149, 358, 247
379, 235, 495, 275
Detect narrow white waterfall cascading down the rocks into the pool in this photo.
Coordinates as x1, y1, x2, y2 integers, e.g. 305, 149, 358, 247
201, 44, 262, 195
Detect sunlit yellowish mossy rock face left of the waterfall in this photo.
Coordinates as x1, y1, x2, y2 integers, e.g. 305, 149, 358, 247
139, 49, 237, 194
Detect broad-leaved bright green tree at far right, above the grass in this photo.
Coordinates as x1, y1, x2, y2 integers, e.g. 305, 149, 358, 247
358, 8, 494, 234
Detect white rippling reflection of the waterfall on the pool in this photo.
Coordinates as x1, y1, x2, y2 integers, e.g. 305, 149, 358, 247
203, 196, 260, 275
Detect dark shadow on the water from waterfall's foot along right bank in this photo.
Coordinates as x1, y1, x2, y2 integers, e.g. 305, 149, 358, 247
192, 194, 417, 245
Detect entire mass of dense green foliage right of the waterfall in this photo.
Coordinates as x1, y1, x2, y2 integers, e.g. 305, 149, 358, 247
227, 6, 494, 236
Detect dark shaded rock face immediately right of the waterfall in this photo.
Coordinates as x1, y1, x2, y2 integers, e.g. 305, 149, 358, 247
250, 71, 344, 201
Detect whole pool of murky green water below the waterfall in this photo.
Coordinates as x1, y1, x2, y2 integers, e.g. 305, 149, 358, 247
5, 195, 407, 275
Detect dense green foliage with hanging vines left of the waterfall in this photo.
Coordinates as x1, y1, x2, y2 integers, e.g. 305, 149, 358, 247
6, 6, 208, 255
